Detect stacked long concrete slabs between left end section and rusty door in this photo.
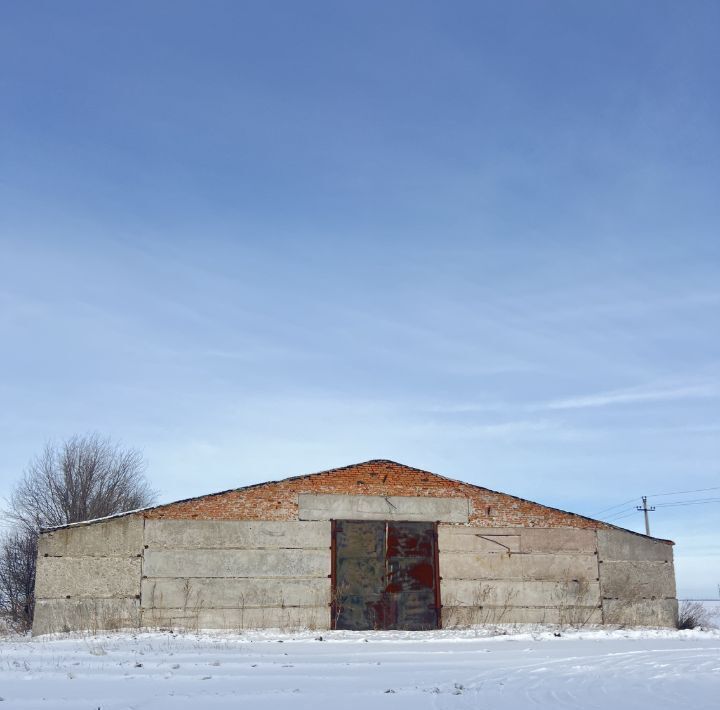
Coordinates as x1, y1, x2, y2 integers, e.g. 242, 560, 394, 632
141, 520, 331, 629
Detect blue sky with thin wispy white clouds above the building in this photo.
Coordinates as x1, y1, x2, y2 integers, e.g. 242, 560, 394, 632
0, 0, 720, 598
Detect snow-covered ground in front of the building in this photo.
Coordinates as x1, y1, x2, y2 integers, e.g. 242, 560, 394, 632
0, 628, 720, 710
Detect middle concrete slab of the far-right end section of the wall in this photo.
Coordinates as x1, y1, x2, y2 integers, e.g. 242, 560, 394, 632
600, 560, 675, 599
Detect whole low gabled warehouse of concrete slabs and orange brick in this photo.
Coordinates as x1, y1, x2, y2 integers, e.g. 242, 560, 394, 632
33, 460, 677, 634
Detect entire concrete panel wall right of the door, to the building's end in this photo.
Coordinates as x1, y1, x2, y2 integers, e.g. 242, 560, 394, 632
438, 525, 677, 628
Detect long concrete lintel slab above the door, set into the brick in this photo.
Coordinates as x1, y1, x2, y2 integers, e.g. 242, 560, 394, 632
298, 493, 471, 523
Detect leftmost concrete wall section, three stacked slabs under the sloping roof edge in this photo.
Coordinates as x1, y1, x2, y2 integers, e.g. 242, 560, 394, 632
33, 514, 144, 634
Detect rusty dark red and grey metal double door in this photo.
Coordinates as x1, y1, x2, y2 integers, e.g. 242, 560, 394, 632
332, 520, 440, 631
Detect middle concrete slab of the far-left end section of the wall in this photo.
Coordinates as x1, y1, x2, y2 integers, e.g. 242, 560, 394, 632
35, 557, 141, 599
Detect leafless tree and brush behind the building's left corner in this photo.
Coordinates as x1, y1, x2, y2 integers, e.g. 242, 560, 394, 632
0, 434, 156, 628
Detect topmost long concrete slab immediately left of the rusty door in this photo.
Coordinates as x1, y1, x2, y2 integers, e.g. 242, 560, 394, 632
145, 520, 331, 550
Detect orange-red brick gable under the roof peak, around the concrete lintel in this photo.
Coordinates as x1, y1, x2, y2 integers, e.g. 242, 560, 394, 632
145, 461, 610, 529
